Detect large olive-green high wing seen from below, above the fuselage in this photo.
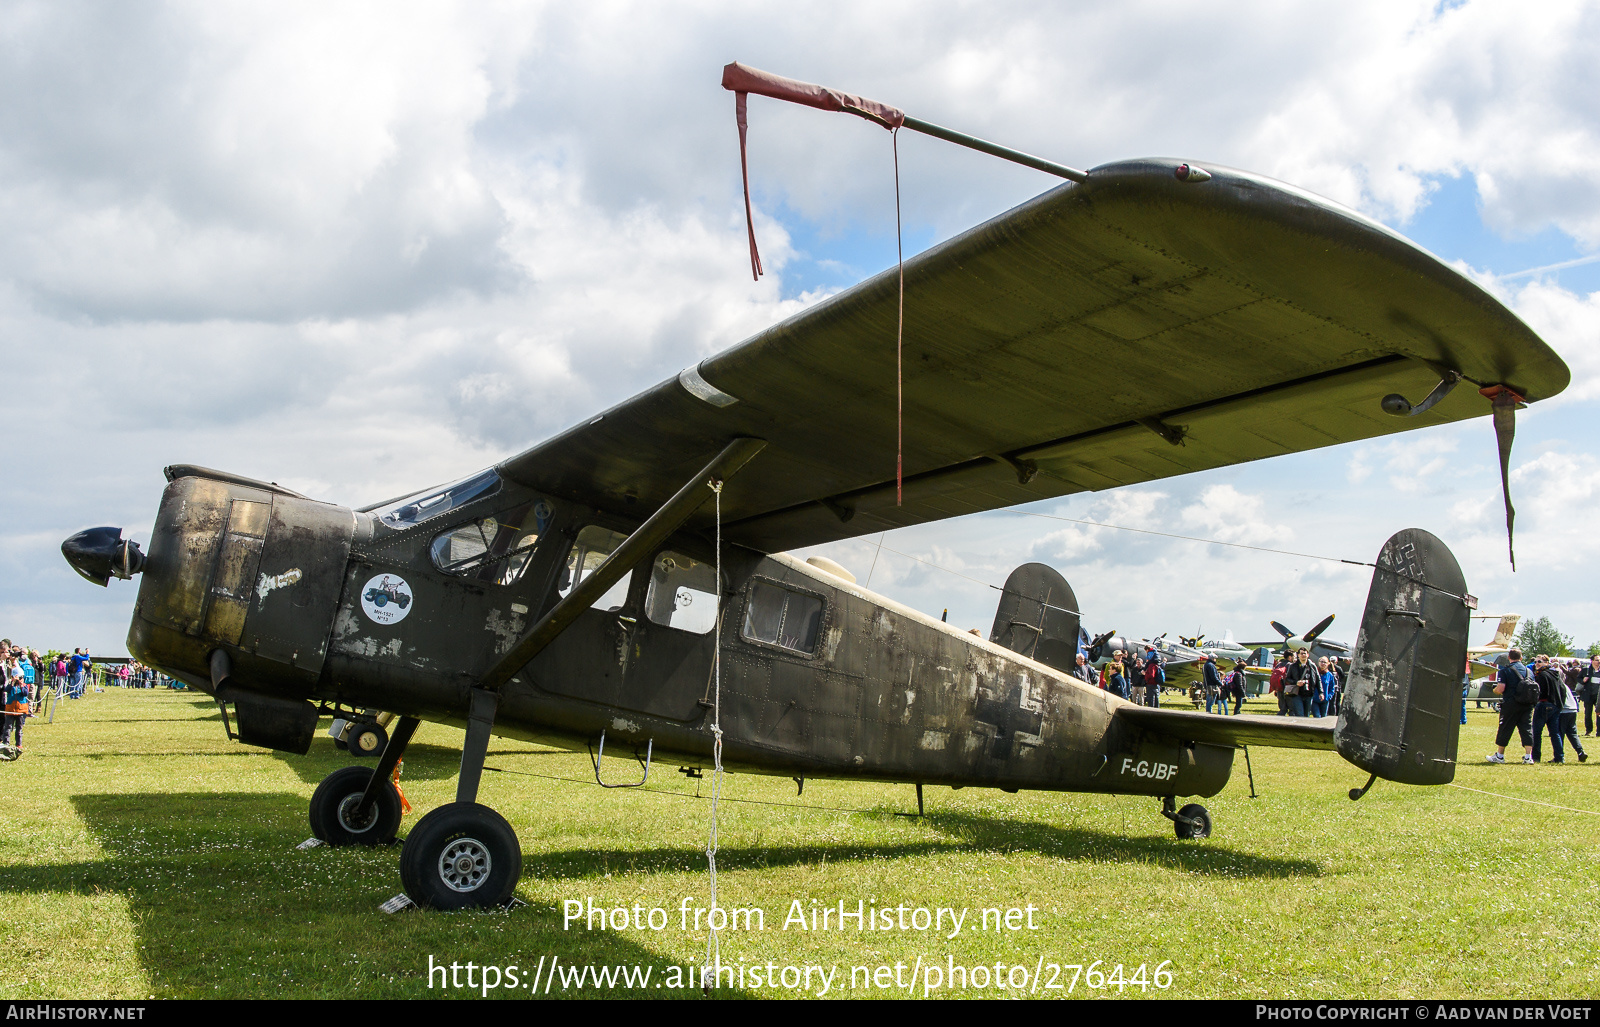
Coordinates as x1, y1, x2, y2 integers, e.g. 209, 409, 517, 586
499, 160, 1570, 552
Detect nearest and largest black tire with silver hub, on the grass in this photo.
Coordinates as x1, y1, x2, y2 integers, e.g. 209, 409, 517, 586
400, 803, 522, 910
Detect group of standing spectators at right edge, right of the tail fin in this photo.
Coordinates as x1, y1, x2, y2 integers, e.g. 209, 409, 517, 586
1462, 649, 1600, 763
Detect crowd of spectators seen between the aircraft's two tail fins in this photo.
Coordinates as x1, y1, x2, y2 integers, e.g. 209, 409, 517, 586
1074, 646, 1350, 717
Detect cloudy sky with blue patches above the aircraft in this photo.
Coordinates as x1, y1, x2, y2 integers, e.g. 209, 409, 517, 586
0, 0, 1600, 654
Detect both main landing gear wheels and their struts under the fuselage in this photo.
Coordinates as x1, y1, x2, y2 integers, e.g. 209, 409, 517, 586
310, 688, 522, 910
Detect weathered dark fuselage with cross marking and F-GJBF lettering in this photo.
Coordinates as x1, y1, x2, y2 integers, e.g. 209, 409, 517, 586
130, 477, 1234, 797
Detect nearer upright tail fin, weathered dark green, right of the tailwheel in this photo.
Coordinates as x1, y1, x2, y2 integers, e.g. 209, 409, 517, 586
1333, 528, 1475, 784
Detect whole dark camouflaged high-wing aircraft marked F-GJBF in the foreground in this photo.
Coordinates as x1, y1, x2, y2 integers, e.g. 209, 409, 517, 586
64, 67, 1570, 909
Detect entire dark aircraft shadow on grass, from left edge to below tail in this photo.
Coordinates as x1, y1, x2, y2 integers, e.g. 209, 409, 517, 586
0, 783, 1320, 997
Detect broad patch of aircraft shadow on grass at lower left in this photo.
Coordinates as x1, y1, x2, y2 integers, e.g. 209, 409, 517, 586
36, 792, 746, 998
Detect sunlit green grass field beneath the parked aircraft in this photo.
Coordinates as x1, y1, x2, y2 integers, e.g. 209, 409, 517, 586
0, 689, 1600, 998
